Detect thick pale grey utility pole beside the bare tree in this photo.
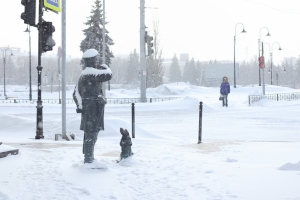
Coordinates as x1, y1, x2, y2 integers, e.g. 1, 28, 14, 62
140, 0, 147, 102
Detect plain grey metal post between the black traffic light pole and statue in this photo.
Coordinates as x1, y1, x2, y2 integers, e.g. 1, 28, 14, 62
61, 0, 67, 138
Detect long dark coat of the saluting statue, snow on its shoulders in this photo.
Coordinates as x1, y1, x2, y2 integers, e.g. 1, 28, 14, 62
73, 67, 112, 132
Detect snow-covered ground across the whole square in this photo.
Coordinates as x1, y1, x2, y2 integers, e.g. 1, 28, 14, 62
0, 83, 300, 200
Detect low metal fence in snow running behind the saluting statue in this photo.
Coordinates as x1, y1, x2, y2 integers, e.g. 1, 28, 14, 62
0, 97, 181, 104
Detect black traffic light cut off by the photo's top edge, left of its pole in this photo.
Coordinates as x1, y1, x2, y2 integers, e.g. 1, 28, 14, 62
21, 0, 36, 26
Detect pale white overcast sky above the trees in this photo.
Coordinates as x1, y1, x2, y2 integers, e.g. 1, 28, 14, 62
0, 0, 300, 65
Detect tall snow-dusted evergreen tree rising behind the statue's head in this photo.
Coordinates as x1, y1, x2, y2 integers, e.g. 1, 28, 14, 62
80, 0, 114, 66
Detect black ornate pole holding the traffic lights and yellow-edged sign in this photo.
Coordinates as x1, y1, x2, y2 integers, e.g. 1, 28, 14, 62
35, 0, 44, 139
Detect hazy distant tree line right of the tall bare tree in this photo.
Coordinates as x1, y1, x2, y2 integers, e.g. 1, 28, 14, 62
169, 55, 300, 88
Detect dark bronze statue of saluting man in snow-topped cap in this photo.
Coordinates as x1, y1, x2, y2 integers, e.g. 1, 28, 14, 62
73, 49, 112, 163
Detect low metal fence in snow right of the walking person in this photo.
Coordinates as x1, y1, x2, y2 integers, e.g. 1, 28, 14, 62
249, 92, 300, 105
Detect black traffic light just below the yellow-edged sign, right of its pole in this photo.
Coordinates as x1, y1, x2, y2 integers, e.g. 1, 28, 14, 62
41, 21, 55, 52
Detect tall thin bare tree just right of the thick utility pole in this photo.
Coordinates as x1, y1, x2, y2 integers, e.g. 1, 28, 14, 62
146, 20, 165, 87
